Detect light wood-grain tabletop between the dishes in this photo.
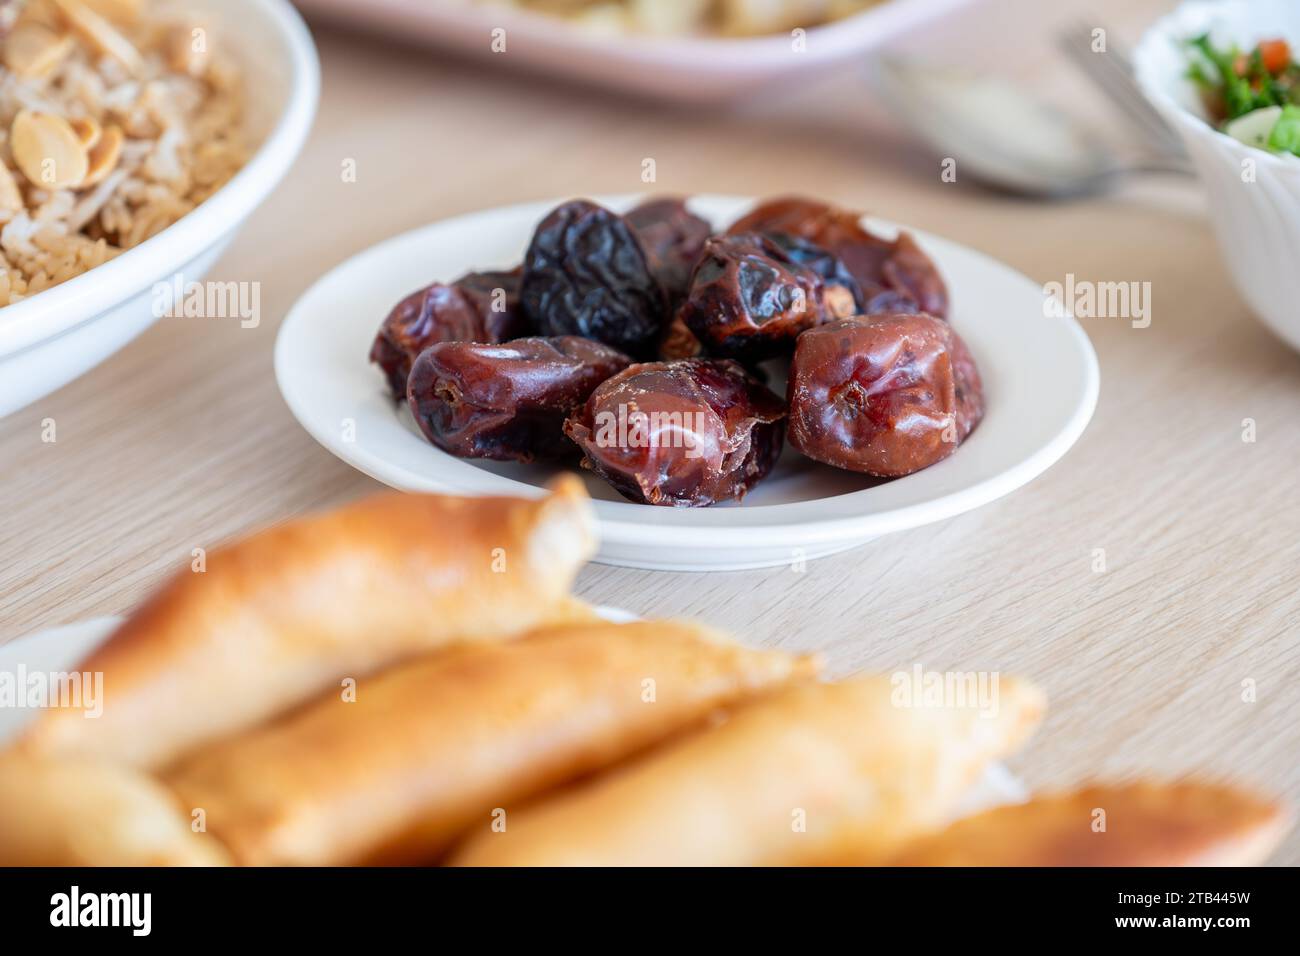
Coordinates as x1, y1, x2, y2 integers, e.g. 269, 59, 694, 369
0, 0, 1300, 864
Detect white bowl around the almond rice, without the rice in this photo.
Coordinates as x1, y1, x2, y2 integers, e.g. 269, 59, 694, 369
0, 0, 320, 416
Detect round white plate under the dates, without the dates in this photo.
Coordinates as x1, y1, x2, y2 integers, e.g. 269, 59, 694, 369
276, 196, 1099, 571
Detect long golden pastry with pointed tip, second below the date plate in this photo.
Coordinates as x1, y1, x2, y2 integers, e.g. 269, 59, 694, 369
164, 622, 813, 865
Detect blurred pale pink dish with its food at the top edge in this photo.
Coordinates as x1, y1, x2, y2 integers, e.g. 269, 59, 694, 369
298, 0, 972, 103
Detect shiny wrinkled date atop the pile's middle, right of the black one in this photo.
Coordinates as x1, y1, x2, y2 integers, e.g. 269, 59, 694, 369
677, 233, 828, 362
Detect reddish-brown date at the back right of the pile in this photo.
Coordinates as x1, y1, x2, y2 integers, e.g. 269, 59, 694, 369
728, 196, 948, 319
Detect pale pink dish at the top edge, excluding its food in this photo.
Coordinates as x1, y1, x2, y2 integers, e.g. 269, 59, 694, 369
298, 0, 972, 103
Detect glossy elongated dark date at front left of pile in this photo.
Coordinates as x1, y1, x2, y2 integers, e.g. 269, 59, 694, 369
407, 336, 632, 462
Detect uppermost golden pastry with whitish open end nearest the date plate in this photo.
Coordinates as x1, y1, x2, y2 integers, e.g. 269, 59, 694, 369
25, 477, 595, 767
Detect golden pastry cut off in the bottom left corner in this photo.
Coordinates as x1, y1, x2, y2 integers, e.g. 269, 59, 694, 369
0, 752, 230, 866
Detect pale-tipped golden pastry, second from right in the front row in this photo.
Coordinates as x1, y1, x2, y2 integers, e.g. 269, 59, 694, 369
452, 676, 1044, 866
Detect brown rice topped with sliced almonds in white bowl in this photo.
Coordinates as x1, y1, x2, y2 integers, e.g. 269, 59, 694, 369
0, 0, 248, 307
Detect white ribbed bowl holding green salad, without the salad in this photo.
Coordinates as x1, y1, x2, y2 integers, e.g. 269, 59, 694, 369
1134, 0, 1300, 349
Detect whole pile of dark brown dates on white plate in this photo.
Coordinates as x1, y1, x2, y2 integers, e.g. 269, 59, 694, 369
371, 198, 984, 506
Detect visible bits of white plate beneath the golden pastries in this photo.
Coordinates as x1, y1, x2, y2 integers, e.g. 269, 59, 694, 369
0, 616, 1026, 817
